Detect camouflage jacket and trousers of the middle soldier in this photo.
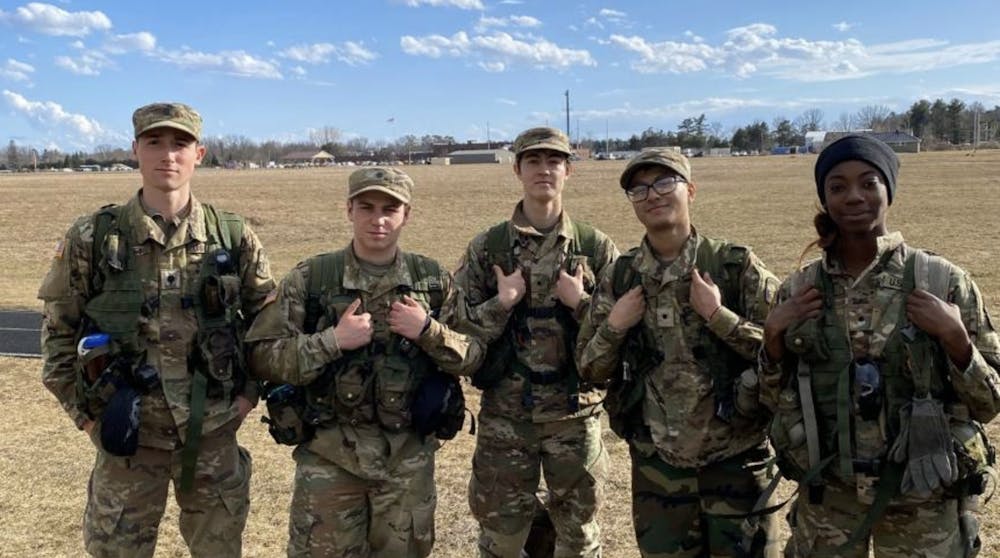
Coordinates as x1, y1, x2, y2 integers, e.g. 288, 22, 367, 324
454, 203, 618, 558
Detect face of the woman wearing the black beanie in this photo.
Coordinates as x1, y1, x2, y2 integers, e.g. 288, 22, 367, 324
823, 161, 889, 237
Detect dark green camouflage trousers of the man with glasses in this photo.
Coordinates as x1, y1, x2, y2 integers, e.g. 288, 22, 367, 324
630, 443, 779, 558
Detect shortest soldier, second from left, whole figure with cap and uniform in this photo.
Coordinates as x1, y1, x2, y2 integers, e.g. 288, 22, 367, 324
247, 167, 483, 558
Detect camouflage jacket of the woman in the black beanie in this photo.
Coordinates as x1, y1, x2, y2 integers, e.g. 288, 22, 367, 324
759, 232, 1000, 434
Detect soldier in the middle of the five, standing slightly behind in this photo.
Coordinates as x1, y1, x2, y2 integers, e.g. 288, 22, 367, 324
455, 128, 618, 558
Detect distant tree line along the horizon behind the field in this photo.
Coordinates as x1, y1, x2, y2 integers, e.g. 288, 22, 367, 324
0, 98, 1000, 170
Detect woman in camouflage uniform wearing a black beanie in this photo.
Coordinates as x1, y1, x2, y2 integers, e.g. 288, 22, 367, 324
760, 135, 1000, 558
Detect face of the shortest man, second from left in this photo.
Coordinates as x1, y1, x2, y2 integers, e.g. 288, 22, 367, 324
347, 191, 410, 263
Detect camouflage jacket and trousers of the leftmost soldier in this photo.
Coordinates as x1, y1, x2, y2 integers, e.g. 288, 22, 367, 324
38, 191, 274, 556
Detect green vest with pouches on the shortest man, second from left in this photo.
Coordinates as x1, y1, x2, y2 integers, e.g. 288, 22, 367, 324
262, 251, 466, 445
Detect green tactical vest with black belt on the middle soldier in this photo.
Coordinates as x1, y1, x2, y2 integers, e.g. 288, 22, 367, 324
472, 221, 597, 412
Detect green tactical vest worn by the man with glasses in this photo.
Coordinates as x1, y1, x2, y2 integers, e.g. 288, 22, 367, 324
604, 237, 752, 440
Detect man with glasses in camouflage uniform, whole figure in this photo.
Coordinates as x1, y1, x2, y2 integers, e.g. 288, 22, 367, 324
577, 149, 777, 557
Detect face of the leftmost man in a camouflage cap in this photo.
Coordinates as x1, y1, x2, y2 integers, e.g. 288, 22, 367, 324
132, 127, 205, 193
